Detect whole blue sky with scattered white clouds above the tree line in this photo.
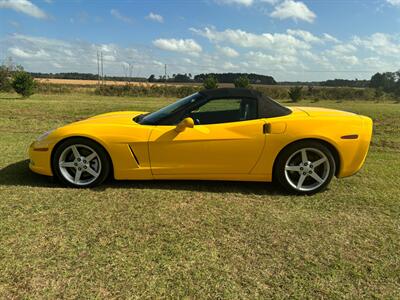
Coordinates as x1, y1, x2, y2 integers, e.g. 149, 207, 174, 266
0, 0, 400, 81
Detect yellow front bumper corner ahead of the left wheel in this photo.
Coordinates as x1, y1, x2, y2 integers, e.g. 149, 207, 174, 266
29, 142, 53, 176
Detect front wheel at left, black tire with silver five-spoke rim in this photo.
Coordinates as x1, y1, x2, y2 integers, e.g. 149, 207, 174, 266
52, 138, 110, 187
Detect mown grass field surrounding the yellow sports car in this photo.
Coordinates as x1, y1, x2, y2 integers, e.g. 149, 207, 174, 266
0, 94, 400, 299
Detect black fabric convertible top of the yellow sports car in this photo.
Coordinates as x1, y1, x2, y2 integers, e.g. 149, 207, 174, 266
200, 88, 292, 118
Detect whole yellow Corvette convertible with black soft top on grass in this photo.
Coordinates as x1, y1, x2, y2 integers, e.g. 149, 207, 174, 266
29, 88, 372, 194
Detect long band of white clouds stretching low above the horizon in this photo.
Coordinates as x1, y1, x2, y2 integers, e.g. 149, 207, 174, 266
1, 28, 400, 81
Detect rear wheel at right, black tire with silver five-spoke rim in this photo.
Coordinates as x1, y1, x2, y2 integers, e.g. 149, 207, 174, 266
273, 140, 336, 195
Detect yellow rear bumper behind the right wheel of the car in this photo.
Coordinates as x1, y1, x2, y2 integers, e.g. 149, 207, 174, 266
338, 116, 373, 177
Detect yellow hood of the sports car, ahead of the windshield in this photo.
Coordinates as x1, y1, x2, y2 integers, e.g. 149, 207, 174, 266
72, 111, 146, 125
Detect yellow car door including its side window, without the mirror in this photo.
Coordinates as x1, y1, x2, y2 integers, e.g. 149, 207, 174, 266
149, 99, 265, 175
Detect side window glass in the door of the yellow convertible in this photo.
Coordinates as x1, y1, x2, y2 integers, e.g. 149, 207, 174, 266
187, 98, 257, 124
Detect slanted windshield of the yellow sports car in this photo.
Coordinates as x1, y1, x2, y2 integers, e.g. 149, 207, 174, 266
136, 93, 200, 125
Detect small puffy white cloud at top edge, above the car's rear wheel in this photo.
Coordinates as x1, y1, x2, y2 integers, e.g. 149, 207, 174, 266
271, 0, 316, 23
